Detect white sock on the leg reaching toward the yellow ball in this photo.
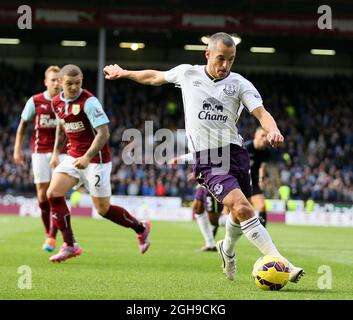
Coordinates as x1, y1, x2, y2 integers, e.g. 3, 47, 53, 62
240, 216, 281, 256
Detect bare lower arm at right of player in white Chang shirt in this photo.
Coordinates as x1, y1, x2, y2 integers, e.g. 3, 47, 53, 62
252, 107, 284, 147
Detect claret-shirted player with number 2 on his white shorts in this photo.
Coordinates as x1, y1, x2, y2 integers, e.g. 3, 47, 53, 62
47, 64, 150, 262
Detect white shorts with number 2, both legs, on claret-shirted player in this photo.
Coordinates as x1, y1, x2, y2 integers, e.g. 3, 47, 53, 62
54, 156, 112, 198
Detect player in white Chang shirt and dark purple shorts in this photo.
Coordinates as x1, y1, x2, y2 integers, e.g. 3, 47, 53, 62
103, 32, 304, 282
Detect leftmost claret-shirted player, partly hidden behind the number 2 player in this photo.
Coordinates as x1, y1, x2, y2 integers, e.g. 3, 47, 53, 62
13, 66, 66, 251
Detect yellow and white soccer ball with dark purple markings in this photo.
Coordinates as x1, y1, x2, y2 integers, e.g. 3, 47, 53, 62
252, 256, 290, 290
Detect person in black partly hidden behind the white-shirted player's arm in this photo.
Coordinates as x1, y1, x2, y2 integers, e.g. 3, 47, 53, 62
244, 127, 271, 227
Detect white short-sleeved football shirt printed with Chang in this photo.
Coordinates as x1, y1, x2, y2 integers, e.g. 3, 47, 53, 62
164, 64, 263, 152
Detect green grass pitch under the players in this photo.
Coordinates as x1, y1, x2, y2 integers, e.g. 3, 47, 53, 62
0, 215, 353, 300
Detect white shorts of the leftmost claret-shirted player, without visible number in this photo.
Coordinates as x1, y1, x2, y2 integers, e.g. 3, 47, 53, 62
32, 152, 66, 184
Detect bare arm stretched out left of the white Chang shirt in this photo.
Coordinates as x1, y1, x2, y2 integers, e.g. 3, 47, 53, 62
103, 64, 167, 86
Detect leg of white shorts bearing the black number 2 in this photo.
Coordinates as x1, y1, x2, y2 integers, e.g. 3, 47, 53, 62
82, 162, 112, 198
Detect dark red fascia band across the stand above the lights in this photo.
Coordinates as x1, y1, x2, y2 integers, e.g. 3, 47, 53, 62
0, 4, 353, 36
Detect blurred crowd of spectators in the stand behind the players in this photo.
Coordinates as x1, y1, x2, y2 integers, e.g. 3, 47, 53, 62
0, 64, 353, 203
